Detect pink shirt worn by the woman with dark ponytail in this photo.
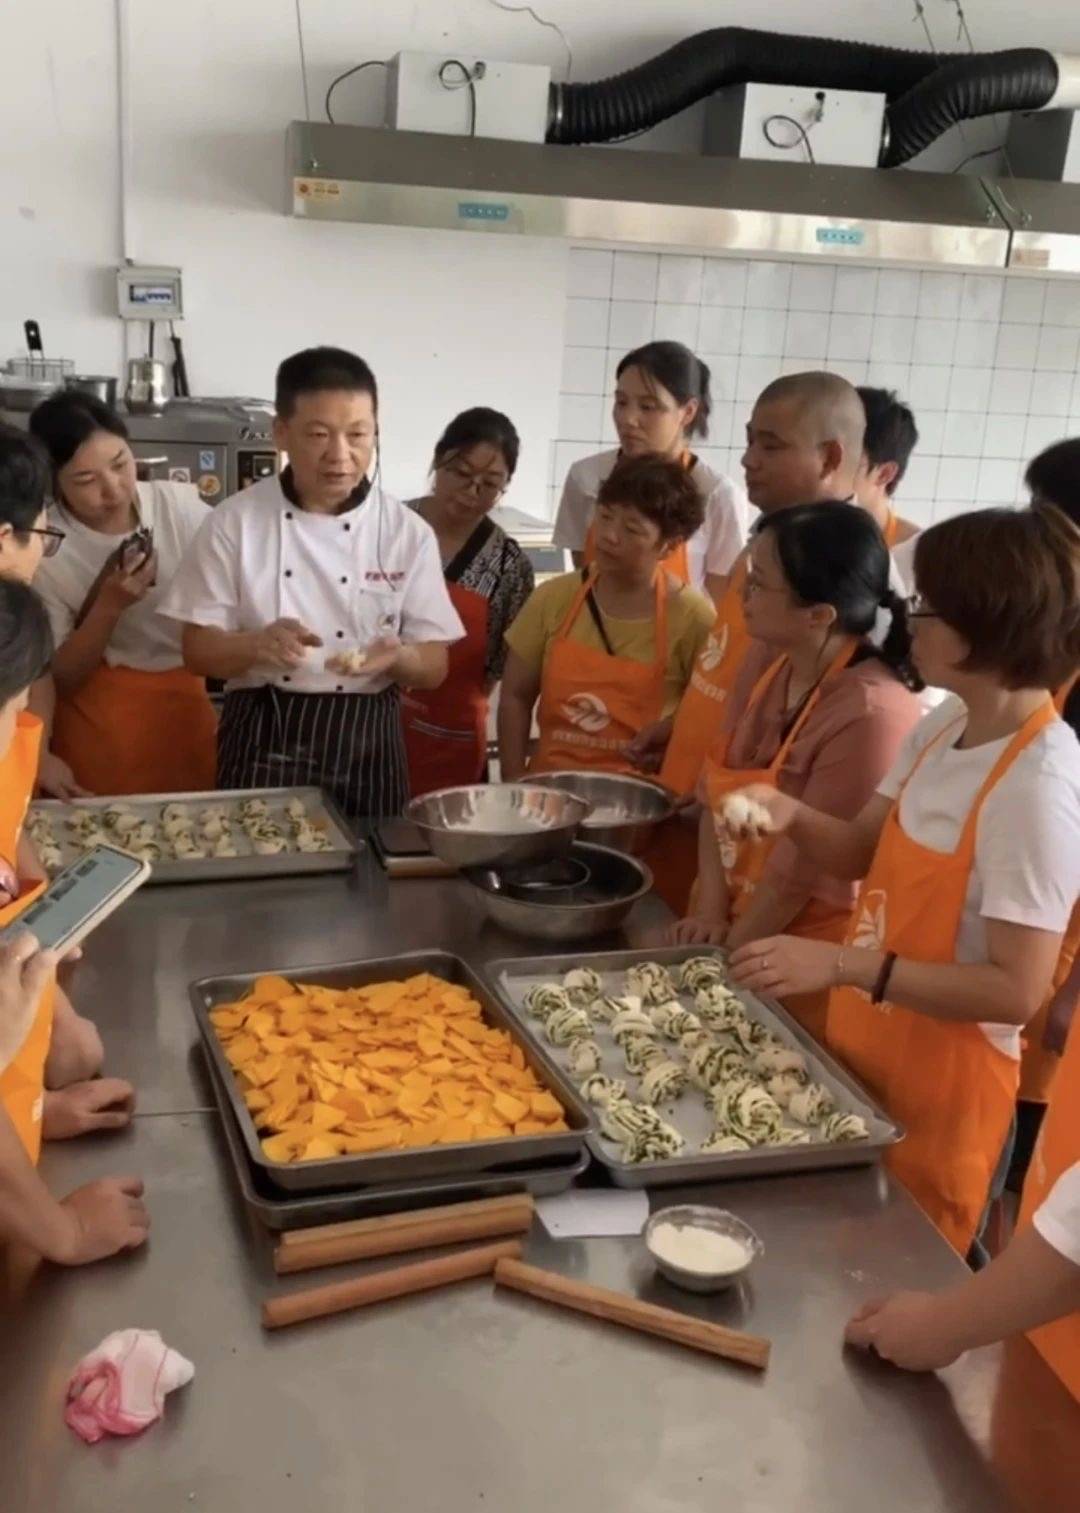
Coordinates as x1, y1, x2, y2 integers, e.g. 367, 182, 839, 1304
725, 643, 923, 909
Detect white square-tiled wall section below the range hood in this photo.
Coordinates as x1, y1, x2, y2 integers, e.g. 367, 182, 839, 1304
551, 248, 1080, 523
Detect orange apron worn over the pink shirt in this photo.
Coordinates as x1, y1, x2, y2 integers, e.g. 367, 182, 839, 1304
702, 640, 859, 1039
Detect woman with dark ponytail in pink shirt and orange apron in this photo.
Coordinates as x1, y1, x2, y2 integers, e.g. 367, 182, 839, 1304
672, 504, 920, 1039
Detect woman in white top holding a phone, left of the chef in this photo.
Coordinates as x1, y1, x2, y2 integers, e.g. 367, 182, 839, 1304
30, 392, 216, 793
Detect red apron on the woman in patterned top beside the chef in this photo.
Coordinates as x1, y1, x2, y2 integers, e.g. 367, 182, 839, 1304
401, 583, 487, 797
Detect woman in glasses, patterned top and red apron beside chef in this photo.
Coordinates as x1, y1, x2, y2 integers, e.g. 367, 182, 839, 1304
401, 409, 532, 797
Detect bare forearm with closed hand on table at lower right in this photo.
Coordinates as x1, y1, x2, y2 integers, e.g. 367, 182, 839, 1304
844, 1224, 1080, 1371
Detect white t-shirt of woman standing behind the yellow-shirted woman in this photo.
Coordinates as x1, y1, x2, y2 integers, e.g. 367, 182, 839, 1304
554, 451, 750, 589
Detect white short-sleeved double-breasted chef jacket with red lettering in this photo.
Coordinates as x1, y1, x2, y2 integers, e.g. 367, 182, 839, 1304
160, 477, 464, 693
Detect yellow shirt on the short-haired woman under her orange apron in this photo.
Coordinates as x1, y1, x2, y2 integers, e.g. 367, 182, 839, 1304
507, 572, 715, 716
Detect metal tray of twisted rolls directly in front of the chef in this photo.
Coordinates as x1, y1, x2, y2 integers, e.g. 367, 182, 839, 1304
30, 788, 356, 884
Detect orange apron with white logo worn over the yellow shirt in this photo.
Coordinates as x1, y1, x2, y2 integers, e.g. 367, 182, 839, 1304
529, 567, 669, 776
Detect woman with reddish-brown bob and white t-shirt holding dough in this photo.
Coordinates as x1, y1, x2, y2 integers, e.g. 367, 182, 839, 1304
732, 504, 1080, 1254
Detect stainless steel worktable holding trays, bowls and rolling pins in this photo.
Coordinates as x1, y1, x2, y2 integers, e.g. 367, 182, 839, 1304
0, 864, 1080, 1513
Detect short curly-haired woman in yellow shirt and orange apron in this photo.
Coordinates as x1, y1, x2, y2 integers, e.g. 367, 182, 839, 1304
499, 457, 714, 781
